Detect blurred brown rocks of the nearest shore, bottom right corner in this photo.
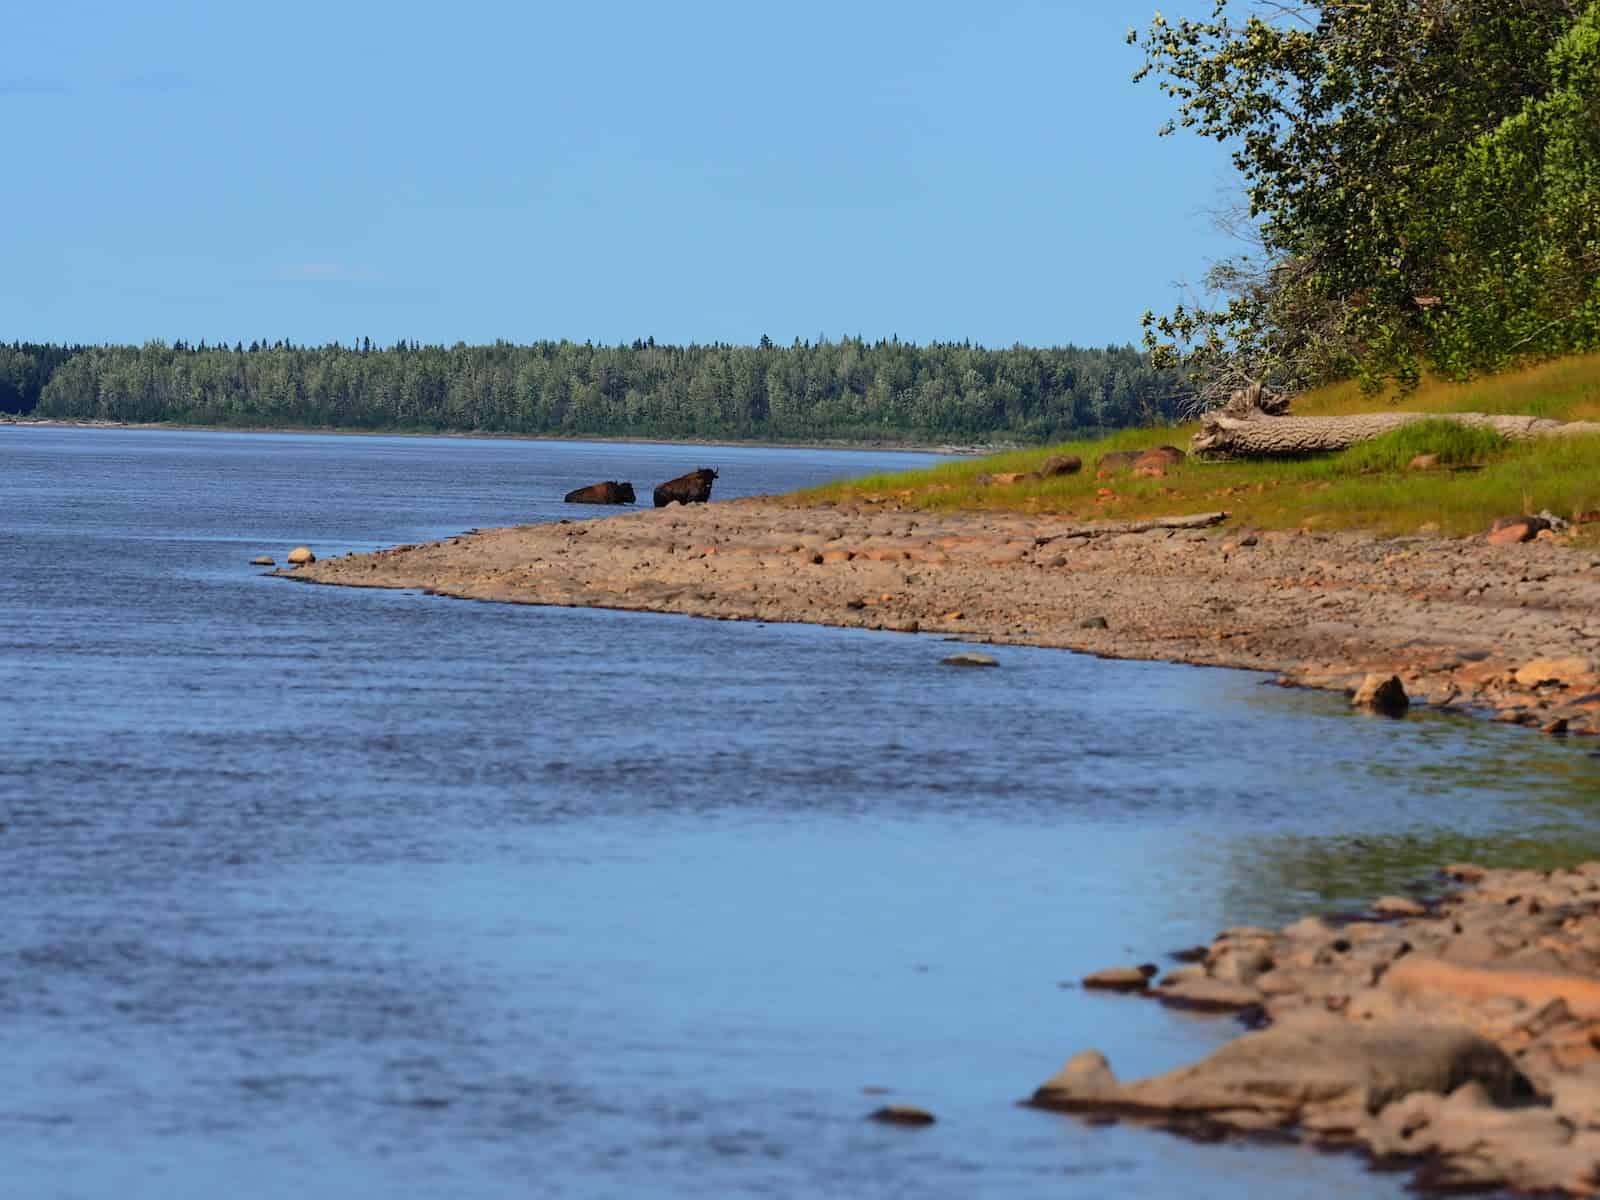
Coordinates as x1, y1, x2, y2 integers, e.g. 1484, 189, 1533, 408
1029, 862, 1600, 1195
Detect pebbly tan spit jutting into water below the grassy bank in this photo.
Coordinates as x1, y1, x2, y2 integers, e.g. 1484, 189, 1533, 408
285, 499, 1600, 733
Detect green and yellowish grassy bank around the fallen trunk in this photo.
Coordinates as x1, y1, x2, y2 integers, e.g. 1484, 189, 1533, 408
800, 355, 1600, 534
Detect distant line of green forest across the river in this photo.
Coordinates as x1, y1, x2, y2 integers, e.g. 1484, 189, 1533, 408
0, 338, 1181, 442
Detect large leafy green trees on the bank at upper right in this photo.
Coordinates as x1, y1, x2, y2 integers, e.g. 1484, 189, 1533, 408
1130, 0, 1600, 398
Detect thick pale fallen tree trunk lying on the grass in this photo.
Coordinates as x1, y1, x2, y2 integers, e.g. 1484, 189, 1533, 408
1192, 413, 1600, 458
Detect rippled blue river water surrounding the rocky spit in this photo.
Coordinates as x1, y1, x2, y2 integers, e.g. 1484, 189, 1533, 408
0, 426, 1600, 1200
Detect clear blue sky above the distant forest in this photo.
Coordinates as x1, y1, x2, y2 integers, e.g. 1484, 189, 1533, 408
0, 0, 1230, 346
